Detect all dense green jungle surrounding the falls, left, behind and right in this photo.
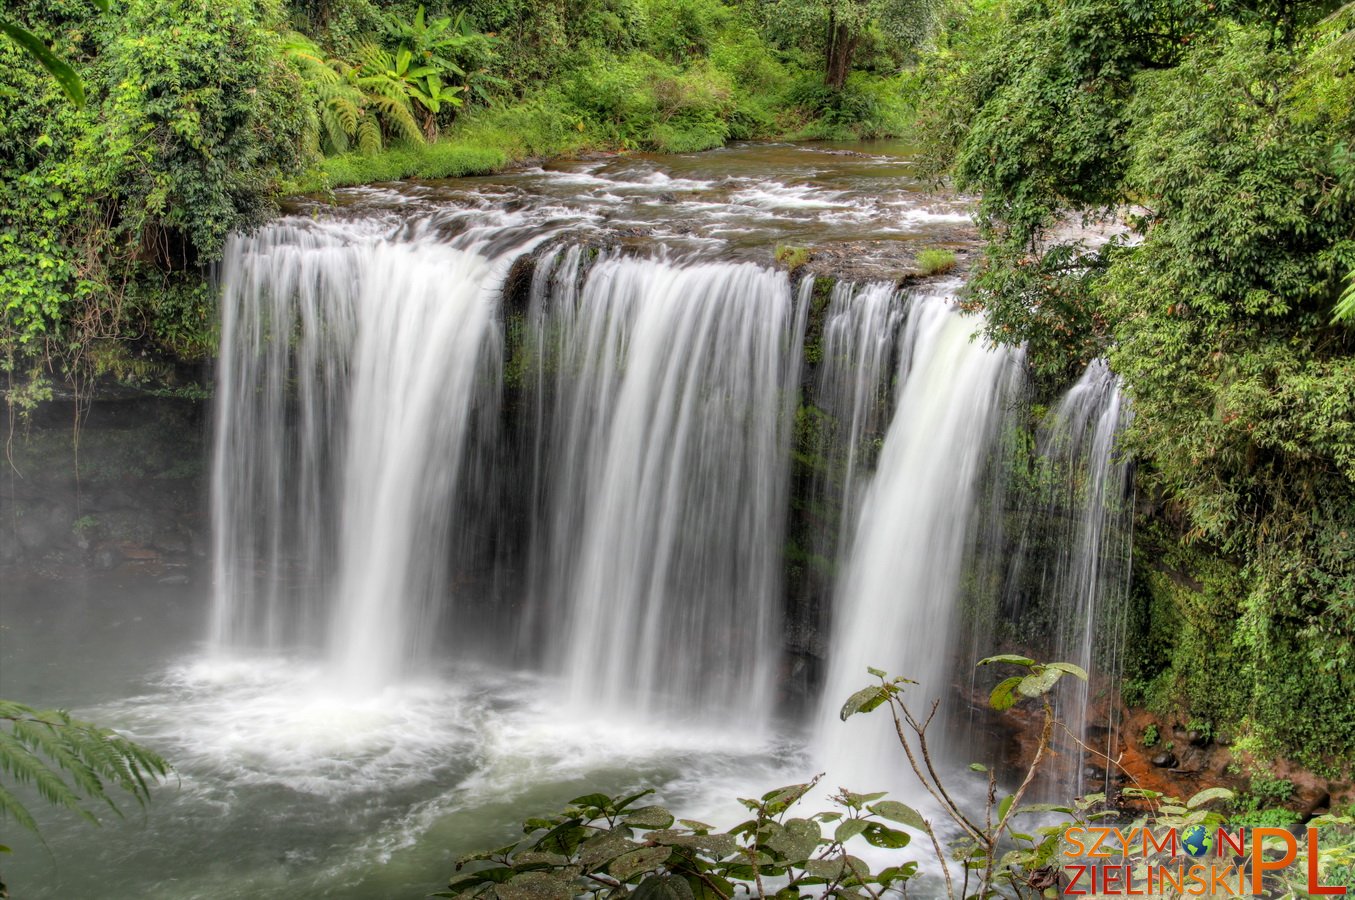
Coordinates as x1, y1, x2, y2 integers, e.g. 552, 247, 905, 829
0, 0, 1355, 786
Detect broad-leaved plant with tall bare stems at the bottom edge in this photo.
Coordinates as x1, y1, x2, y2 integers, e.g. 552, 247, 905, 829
435, 656, 1112, 900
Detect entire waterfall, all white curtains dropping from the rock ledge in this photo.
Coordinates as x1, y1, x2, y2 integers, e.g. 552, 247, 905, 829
211, 207, 1129, 789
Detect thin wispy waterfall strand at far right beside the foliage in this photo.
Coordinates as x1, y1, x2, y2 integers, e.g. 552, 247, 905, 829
1009, 359, 1133, 797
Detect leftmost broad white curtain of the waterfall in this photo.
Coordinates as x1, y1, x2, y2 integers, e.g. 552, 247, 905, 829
213, 222, 501, 687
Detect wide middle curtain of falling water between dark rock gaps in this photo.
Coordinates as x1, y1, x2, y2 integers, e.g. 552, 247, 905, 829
531, 258, 799, 727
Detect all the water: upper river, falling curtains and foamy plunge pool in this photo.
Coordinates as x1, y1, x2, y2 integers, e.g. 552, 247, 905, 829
0, 145, 1127, 900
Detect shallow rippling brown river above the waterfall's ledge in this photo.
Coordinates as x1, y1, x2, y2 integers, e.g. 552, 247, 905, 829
297, 141, 974, 279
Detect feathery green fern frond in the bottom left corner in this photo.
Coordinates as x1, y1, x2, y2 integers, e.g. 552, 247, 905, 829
0, 701, 169, 832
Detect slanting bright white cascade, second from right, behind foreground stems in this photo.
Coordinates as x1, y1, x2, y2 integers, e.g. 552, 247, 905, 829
816, 297, 1019, 790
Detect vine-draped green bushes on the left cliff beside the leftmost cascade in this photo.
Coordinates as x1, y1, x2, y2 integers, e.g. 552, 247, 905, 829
0, 0, 306, 403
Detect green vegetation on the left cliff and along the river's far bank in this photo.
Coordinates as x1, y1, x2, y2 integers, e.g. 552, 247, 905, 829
0, 0, 904, 407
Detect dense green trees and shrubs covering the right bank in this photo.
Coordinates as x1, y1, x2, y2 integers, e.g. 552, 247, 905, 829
917, 0, 1355, 769
